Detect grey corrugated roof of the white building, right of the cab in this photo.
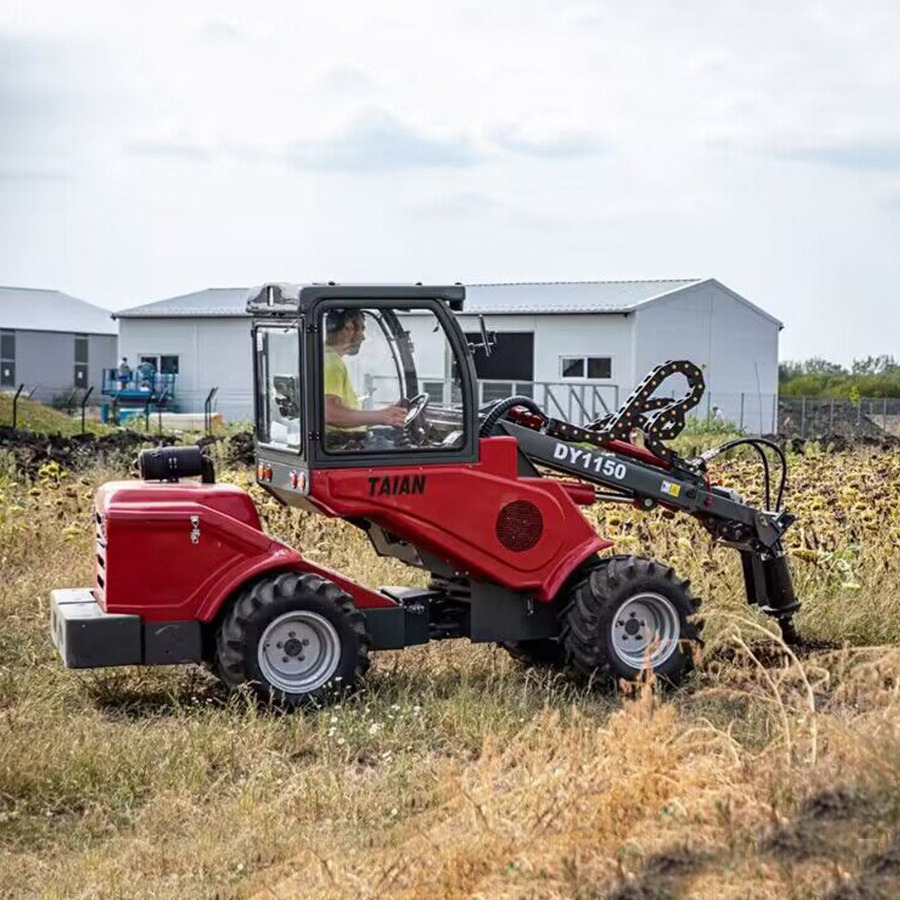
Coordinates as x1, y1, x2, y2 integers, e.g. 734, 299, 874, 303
465, 278, 704, 314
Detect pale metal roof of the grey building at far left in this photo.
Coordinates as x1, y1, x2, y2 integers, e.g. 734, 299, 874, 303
0, 287, 118, 334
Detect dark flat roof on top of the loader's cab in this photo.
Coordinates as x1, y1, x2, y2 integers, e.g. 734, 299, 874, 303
247, 281, 466, 316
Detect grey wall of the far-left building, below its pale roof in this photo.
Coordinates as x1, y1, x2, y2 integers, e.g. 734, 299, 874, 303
3, 329, 116, 402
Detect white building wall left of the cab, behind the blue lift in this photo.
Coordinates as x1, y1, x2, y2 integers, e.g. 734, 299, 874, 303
119, 317, 253, 422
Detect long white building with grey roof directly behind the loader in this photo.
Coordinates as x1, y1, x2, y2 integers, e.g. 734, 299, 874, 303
117, 278, 782, 431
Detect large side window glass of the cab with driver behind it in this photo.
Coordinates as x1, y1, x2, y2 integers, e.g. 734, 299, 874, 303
320, 307, 466, 453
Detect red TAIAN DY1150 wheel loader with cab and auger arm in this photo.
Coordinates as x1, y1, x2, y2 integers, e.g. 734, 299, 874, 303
51, 284, 799, 707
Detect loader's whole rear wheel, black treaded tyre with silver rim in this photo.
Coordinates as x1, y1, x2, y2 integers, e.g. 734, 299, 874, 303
216, 572, 369, 708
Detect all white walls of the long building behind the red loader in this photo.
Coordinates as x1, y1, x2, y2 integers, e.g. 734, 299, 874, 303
118, 283, 778, 431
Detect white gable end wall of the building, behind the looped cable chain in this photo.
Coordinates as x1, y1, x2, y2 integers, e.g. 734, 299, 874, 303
631, 283, 779, 431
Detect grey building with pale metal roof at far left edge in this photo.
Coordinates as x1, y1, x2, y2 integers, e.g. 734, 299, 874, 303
0, 287, 118, 400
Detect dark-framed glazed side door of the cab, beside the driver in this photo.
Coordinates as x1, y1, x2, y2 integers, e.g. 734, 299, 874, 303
307, 297, 478, 469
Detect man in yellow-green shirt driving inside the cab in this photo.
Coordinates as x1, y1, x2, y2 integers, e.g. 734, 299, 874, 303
323, 309, 406, 432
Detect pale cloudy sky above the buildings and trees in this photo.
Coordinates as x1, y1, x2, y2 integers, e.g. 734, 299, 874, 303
0, 0, 900, 363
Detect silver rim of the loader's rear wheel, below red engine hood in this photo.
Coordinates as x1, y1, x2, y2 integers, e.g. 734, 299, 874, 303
257, 610, 341, 694
